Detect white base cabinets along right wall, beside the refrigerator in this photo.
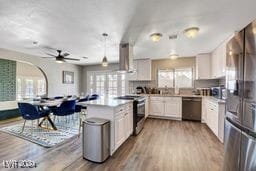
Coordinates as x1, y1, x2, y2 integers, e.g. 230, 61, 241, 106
205, 99, 225, 142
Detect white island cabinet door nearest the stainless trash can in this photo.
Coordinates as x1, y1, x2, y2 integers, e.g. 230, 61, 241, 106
115, 114, 125, 149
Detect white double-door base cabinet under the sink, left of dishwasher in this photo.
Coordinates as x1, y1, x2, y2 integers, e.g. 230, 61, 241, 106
150, 97, 182, 120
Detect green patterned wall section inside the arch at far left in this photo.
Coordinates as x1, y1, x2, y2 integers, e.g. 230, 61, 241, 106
0, 59, 16, 102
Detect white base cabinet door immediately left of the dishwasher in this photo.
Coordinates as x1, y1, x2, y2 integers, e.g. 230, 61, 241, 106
164, 101, 181, 118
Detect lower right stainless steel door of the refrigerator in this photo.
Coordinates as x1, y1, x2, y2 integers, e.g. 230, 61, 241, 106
240, 132, 256, 171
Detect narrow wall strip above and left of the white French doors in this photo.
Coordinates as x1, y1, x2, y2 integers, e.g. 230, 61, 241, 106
81, 63, 119, 94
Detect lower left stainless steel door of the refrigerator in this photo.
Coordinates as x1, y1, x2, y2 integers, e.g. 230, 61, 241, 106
223, 120, 242, 171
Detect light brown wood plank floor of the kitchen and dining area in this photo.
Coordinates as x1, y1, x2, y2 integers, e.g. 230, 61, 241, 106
0, 119, 223, 171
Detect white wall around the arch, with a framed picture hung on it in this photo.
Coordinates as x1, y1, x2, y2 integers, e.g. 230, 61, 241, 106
0, 48, 82, 96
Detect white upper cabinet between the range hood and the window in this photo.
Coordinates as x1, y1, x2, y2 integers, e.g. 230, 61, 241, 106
128, 59, 151, 81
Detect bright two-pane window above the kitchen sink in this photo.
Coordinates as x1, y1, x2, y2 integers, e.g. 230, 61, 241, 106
158, 68, 193, 88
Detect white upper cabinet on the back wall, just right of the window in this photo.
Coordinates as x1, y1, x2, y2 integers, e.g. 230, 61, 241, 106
196, 53, 211, 80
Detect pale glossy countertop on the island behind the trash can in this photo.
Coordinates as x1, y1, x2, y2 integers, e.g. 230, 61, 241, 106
77, 97, 133, 107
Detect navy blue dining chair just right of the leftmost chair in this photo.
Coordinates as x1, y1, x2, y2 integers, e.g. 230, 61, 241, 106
51, 100, 76, 124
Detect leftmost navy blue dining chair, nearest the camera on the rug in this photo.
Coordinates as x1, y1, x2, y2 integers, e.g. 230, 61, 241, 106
18, 102, 50, 133
